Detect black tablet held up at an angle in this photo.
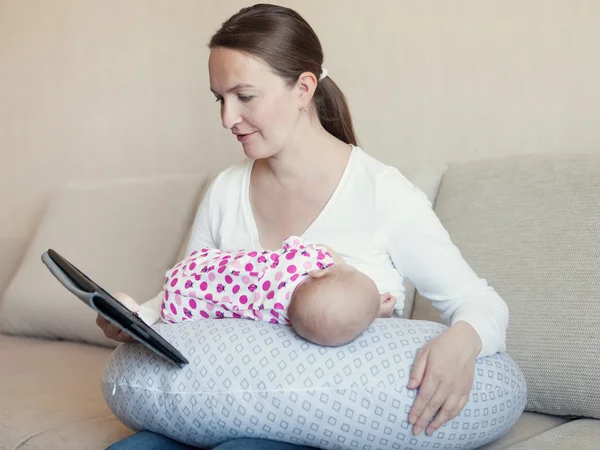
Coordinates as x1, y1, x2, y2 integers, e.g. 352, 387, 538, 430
42, 249, 189, 368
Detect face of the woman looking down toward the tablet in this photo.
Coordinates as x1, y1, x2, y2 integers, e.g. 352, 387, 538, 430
208, 47, 302, 159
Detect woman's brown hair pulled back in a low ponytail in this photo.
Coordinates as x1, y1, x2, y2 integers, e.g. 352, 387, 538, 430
209, 4, 357, 145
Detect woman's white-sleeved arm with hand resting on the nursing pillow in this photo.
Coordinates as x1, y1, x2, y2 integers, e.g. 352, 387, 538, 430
377, 166, 508, 435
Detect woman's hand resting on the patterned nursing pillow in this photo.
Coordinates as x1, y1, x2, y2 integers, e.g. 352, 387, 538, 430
408, 321, 482, 435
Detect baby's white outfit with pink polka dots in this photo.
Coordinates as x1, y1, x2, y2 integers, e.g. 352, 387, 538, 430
160, 236, 334, 324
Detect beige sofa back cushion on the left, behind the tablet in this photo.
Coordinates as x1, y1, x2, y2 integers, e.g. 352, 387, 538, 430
0, 176, 207, 346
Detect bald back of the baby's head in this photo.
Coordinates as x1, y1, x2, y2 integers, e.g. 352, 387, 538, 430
288, 264, 380, 347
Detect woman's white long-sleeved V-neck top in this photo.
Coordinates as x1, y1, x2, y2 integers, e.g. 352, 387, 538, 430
141, 147, 508, 356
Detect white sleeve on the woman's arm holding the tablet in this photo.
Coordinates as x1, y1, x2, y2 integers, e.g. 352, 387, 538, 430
139, 174, 216, 325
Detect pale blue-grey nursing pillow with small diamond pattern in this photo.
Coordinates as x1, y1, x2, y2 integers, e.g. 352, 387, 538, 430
102, 318, 527, 450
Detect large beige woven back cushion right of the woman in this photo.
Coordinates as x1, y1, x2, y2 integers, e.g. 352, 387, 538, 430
413, 155, 600, 417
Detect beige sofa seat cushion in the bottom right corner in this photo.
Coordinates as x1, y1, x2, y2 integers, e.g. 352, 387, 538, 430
509, 419, 600, 450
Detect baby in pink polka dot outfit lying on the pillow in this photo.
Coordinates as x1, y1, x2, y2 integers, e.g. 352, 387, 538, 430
160, 236, 396, 346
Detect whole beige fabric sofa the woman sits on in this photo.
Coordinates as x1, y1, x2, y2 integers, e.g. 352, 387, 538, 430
0, 154, 600, 450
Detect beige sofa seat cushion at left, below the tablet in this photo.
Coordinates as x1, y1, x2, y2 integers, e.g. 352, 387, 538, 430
0, 334, 131, 449
